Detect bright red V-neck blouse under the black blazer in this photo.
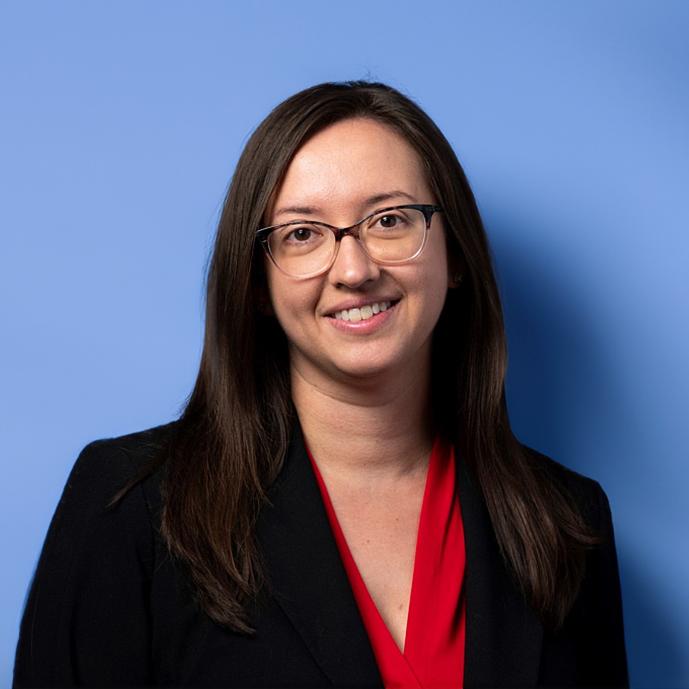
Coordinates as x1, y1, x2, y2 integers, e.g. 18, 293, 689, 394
307, 439, 466, 689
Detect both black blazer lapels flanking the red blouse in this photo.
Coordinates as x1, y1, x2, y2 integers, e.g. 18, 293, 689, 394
258, 425, 542, 689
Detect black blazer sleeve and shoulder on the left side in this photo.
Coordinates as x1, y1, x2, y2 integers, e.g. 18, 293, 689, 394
13, 441, 154, 688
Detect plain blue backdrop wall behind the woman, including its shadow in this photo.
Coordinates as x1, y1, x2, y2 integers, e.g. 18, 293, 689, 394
0, 0, 689, 687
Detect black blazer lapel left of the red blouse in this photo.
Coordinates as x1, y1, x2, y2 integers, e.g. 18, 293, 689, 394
258, 424, 383, 687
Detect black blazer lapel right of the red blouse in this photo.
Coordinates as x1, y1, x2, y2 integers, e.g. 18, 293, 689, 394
457, 456, 543, 689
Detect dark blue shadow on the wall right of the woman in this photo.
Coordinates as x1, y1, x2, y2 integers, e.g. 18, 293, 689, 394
490, 218, 687, 689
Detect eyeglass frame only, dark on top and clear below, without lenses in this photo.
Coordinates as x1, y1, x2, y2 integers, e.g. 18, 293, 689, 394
256, 203, 443, 280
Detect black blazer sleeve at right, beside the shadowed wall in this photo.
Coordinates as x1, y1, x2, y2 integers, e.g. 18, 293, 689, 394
580, 482, 629, 687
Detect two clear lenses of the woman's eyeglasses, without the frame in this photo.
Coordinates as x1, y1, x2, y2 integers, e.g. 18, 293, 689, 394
268, 208, 426, 277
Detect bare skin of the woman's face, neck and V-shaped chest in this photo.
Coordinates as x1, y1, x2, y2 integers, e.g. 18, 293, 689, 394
266, 118, 449, 649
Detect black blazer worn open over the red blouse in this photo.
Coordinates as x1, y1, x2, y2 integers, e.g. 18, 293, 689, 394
14, 424, 628, 687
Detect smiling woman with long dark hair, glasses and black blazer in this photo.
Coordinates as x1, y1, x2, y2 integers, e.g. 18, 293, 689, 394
15, 82, 628, 687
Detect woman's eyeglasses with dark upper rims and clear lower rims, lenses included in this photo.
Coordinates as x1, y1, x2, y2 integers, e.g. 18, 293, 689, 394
256, 203, 442, 278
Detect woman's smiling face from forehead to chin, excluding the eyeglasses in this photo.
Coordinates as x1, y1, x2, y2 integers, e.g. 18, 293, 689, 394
265, 118, 448, 384
